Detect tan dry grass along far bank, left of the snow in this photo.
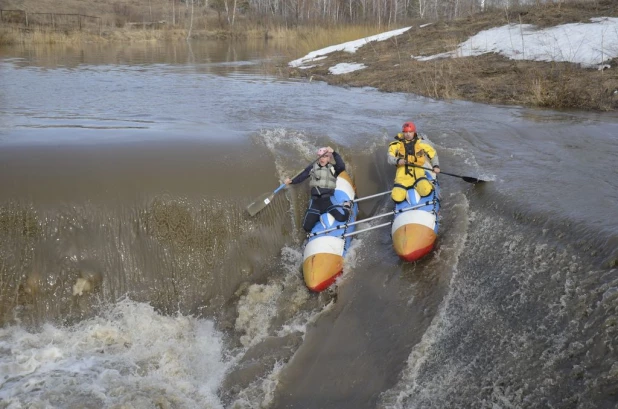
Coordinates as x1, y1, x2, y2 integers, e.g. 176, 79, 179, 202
0, 0, 383, 45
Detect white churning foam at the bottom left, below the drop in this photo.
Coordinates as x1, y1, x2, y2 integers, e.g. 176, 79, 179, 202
0, 300, 232, 408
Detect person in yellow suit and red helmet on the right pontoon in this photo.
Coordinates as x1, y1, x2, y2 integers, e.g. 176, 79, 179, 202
388, 122, 440, 203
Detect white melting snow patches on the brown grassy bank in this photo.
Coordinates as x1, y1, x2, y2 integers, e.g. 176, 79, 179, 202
289, 17, 618, 75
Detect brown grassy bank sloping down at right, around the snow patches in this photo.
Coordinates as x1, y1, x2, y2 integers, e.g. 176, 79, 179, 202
287, 1, 618, 111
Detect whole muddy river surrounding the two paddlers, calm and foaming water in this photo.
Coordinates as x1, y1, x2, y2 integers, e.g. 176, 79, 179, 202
0, 39, 618, 409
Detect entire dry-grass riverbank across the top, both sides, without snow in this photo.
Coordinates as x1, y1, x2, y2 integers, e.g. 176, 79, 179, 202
0, 0, 618, 111
